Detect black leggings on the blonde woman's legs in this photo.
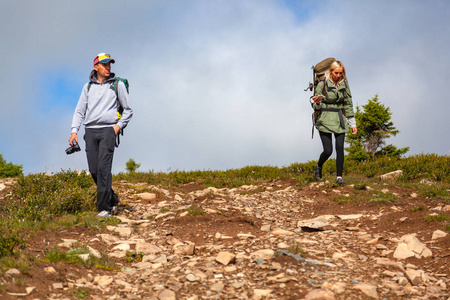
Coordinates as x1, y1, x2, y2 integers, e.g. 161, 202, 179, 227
317, 131, 345, 176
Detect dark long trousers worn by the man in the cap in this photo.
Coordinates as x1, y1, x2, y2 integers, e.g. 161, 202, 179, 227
84, 127, 117, 211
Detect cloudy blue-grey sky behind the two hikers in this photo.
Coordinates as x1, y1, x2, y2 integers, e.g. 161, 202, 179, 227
0, 0, 450, 173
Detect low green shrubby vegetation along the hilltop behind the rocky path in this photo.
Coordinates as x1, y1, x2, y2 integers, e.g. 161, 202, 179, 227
0, 154, 450, 266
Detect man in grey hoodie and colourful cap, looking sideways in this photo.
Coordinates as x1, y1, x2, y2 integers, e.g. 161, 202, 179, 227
69, 53, 133, 217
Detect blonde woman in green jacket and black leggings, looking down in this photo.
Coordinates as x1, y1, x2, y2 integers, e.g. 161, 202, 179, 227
312, 60, 357, 185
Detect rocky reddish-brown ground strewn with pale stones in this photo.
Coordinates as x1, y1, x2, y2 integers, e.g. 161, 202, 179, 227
0, 180, 450, 299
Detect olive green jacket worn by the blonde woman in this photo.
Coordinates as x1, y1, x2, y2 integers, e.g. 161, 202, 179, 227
312, 79, 355, 133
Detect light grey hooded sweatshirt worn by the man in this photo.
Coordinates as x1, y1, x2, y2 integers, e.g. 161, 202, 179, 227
72, 70, 133, 133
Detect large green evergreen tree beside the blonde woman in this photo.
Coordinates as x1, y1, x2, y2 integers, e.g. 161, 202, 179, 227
345, 94, 409, 161
